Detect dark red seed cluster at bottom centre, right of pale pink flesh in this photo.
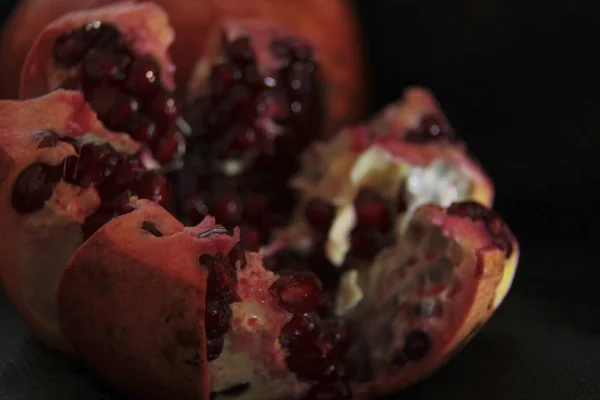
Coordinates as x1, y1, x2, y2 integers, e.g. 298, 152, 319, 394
269, 271, 354, 400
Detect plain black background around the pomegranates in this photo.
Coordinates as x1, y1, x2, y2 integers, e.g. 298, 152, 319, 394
0, 0, 600, 400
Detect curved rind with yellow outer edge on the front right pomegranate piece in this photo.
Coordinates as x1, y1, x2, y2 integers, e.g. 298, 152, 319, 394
354, 205, 519, 399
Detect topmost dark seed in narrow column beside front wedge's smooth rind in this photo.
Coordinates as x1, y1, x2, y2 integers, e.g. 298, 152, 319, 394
200, 254, 237, 301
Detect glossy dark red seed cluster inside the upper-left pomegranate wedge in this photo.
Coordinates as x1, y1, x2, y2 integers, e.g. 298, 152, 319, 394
52, 22, 184, 164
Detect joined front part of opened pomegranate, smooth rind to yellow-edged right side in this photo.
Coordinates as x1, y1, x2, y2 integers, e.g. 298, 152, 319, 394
58, 200, 519, 400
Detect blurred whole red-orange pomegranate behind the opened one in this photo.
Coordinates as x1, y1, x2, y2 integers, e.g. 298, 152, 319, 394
0, 0, 366, 133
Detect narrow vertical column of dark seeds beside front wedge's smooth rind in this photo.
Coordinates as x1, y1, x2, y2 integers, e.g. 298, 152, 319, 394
200, 247, 243, 361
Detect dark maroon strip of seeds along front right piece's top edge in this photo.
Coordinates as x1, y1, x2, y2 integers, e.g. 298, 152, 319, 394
447, 201, 513, 257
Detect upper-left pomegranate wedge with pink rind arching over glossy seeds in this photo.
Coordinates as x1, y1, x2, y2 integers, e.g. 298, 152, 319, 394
21, 3, 187, 164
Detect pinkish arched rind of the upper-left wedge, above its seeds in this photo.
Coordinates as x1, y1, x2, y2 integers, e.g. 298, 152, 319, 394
20, 1, 175, 99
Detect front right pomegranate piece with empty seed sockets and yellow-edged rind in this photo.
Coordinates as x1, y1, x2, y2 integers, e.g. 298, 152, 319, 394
346, 201, 519, 398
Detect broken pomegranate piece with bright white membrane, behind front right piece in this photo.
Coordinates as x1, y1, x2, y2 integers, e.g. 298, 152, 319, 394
276, 88, 493, 272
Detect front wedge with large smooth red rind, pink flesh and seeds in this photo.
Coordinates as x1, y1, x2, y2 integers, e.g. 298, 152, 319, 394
58, 200, 358, 399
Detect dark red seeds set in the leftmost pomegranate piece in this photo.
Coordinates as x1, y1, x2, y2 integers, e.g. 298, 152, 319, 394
12, 131, 171, 238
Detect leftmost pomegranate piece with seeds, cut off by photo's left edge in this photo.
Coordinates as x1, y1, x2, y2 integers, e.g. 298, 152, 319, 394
0, 90, 170, 349
